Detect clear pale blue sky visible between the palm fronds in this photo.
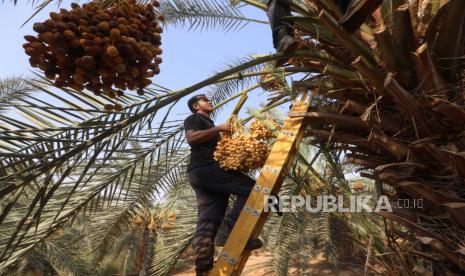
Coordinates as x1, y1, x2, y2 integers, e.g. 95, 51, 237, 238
0, 0, 280, 123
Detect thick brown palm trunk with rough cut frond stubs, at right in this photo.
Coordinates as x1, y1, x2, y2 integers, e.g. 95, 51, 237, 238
272, 0, 465, 270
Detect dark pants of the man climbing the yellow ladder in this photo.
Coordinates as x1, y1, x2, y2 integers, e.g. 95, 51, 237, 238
188, 162, 255, 275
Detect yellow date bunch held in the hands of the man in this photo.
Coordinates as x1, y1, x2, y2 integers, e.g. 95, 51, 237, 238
214, 116, 280, 172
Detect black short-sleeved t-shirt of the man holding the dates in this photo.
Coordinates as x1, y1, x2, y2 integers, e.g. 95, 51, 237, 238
184, 113, 219, 170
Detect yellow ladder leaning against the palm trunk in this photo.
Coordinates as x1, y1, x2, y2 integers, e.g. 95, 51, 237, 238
209, 93, 310, 276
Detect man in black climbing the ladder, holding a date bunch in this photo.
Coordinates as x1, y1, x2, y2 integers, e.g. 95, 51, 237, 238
184, 95, 263, 276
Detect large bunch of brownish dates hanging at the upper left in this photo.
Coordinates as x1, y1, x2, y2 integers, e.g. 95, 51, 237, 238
23, 0, 163, 109
